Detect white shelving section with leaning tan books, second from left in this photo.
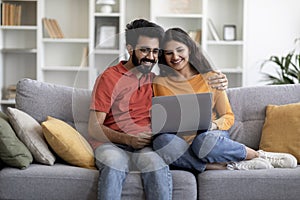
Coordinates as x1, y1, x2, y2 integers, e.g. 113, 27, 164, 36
38, 0, 89, 88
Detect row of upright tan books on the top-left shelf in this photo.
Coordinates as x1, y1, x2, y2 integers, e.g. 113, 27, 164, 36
1, 3, 21, 26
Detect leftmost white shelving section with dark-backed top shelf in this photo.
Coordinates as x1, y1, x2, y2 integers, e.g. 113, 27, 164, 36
0, 0, 38, 108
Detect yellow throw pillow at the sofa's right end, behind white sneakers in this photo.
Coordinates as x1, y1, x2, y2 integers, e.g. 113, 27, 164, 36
259, 103, 300, 162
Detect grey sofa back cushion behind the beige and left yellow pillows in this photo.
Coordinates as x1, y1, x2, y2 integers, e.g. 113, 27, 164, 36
16, 78, 91, 138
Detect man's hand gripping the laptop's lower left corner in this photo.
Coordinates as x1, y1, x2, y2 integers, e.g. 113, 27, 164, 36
127, 132, 152, 149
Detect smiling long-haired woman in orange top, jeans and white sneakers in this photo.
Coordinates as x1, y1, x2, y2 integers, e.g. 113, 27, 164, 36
153, 28, 297, 172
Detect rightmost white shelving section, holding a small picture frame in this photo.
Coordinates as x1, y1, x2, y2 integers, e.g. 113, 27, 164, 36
202, 0, 246, 87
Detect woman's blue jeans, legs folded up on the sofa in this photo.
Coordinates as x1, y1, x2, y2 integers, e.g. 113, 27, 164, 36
153, 130, 246, 172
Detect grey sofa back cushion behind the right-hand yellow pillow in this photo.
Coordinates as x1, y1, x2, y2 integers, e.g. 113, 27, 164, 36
227, 84, 300, 149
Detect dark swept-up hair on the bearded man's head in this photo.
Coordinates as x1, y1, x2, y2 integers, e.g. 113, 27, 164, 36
125, 19, 164, 48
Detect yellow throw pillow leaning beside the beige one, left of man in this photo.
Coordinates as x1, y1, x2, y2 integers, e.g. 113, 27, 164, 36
42, 116, 95, 169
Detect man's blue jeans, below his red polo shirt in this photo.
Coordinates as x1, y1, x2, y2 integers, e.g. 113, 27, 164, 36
95, 143, 173, 200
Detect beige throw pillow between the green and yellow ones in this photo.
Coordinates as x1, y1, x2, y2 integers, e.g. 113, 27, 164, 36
7, 107, 55, 165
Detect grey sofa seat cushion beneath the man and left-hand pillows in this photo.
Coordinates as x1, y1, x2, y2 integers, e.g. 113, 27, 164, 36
0, 163, 197, 200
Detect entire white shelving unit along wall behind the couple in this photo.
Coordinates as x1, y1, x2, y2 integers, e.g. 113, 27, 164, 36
0, 0, 247, 111
